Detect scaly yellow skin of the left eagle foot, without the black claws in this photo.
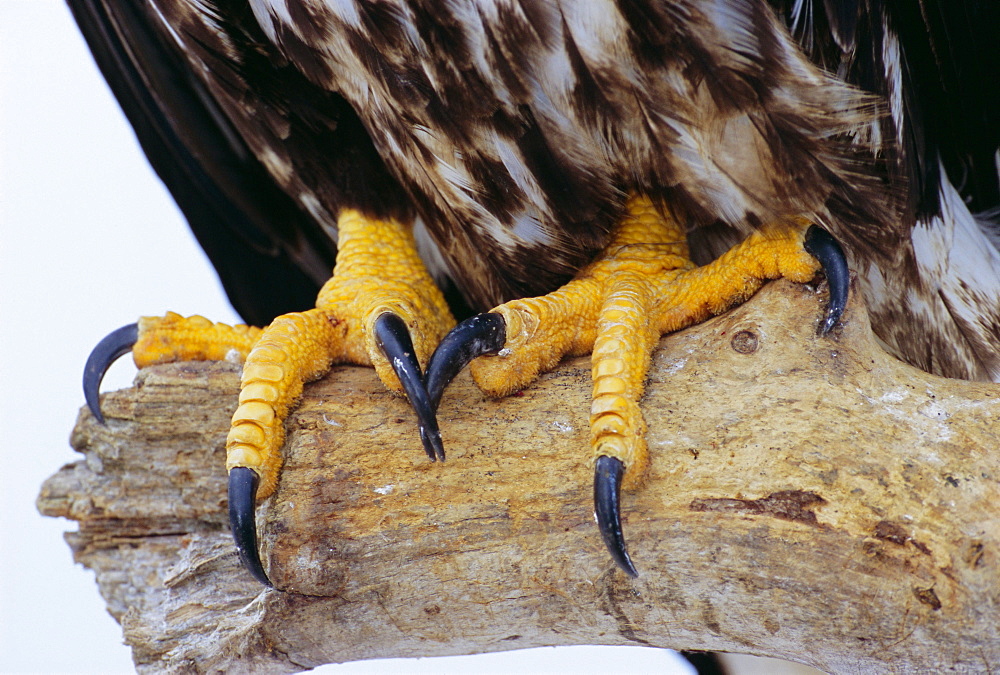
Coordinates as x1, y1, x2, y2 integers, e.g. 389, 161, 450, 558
133, 210, 455, 499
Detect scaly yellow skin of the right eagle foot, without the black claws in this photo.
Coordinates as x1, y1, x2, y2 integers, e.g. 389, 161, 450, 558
471, 197, 819, 488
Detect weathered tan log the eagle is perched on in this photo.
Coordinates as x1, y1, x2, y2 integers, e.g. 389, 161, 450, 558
39, 282, 1000, 672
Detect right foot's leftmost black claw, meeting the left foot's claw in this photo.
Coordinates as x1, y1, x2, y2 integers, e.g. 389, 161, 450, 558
426, 312, 507, 410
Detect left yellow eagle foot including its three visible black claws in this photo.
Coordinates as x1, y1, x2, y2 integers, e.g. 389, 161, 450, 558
84, 211, 455, 586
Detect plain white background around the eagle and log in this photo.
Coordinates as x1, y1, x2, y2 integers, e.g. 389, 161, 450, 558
0, 0, 812, 675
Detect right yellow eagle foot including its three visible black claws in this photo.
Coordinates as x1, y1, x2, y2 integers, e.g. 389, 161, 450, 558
427, 197, 848, 576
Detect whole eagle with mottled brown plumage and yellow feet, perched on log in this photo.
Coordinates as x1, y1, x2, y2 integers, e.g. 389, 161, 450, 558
78, 0, 1000, 612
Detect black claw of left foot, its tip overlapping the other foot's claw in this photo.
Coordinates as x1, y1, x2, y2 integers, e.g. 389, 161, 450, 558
374, 312, 444, 462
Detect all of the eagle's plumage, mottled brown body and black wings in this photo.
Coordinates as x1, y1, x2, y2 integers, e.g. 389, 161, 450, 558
70, 0, 1000, 379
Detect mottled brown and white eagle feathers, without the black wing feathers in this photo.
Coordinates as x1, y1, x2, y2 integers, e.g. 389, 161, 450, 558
74, 0, 1000, 378
